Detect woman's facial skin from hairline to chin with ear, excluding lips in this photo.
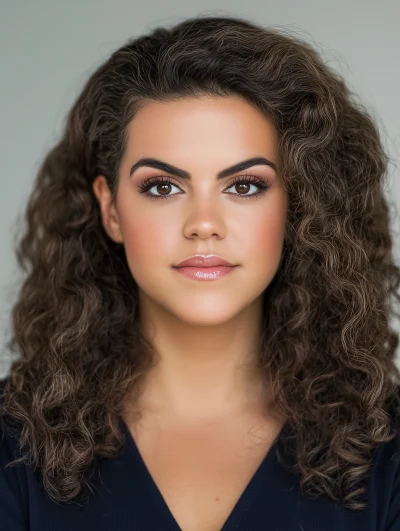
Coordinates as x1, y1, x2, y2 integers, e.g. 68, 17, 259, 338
93, 97, 287, 325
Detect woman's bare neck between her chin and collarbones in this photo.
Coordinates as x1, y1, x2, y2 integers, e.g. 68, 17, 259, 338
130, 290, 266, 420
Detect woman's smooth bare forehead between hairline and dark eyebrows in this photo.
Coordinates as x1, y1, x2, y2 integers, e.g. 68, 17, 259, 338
127, 96, 278, 159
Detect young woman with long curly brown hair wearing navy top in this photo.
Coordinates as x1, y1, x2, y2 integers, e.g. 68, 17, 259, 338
0, 12, 400, 531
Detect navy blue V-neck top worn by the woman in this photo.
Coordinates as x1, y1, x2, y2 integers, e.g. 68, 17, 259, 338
0, 374, 400, 531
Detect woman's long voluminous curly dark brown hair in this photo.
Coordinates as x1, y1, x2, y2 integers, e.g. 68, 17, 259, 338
1, 13, 400, 510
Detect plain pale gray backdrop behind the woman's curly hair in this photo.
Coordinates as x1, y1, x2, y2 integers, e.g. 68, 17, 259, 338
0, 0, 400, 377
